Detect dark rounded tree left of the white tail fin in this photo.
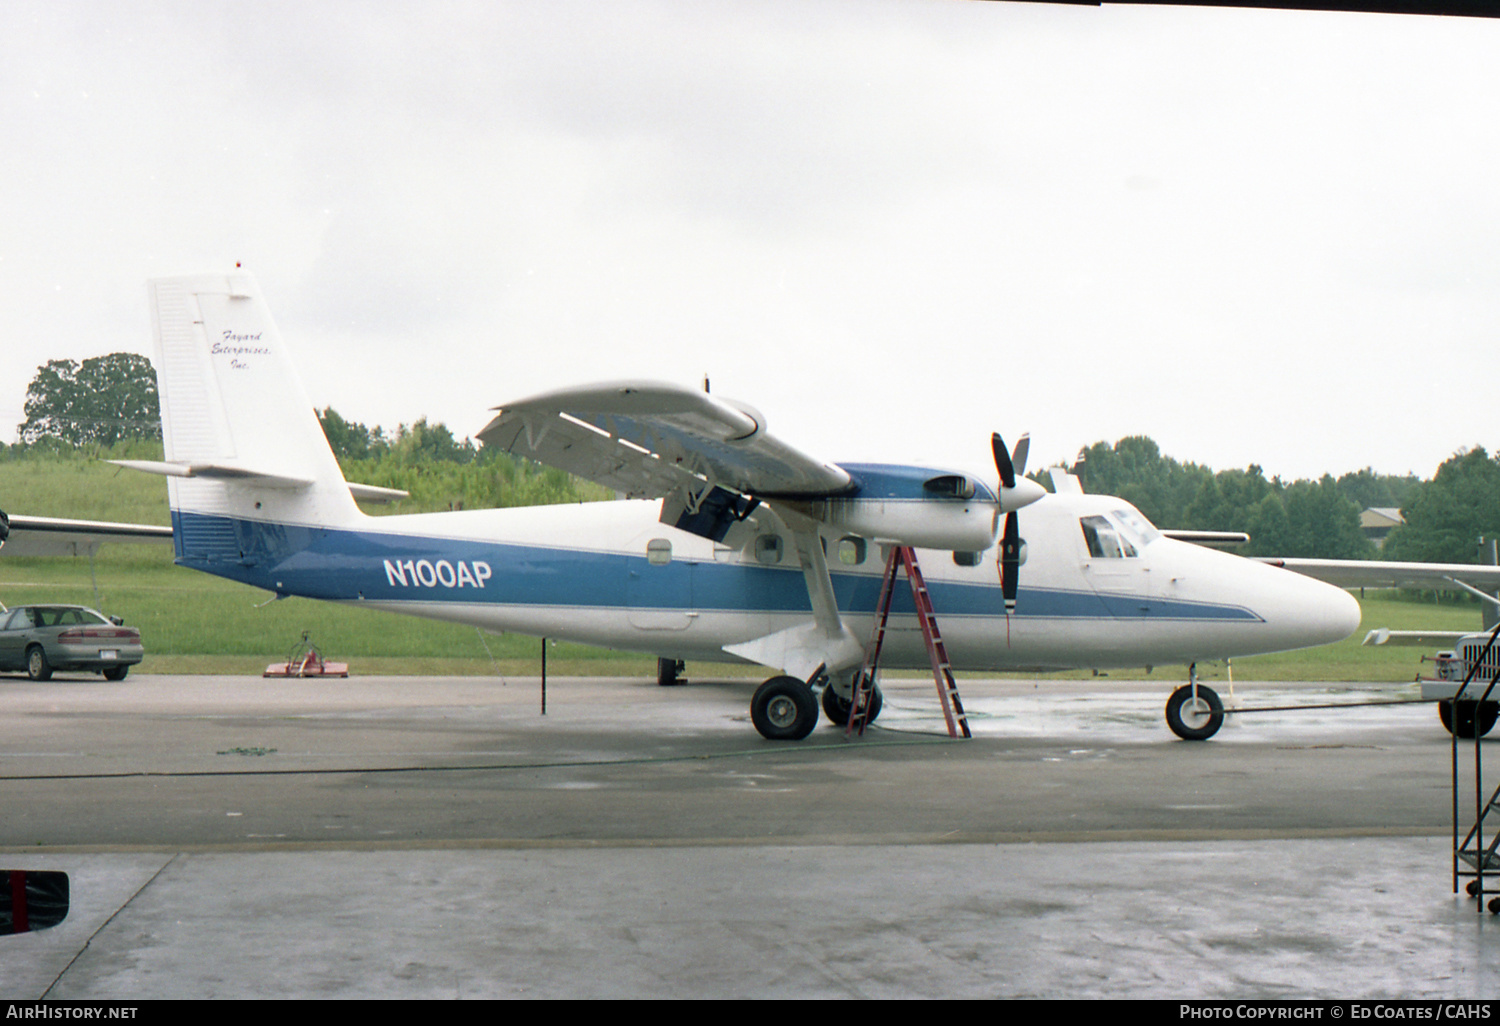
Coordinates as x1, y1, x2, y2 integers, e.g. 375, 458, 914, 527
21, 353, 162, 446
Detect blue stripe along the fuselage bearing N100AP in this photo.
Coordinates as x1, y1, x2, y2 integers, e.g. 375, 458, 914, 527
173, 510, 1260, 621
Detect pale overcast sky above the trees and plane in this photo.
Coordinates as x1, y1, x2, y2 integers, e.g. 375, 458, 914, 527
0, 0, 1500, 489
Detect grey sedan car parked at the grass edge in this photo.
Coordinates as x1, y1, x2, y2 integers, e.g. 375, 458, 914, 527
0, 606, 146, 681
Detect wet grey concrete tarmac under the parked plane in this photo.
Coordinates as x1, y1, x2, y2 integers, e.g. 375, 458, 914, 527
0, 666, 1500, 1001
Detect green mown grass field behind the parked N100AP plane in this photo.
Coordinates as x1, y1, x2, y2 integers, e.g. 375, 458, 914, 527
0, 459, 1479, 683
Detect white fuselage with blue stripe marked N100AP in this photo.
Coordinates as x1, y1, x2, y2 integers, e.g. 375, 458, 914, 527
174, 495, 1359, 671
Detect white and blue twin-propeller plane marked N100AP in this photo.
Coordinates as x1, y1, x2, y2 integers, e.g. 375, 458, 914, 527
108, 272, 1359, 740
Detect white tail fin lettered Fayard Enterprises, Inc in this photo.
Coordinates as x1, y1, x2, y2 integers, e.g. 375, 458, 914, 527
141, 272, 363, 561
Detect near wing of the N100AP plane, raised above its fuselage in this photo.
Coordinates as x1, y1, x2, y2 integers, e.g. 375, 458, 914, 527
479, 381, 854, 500
